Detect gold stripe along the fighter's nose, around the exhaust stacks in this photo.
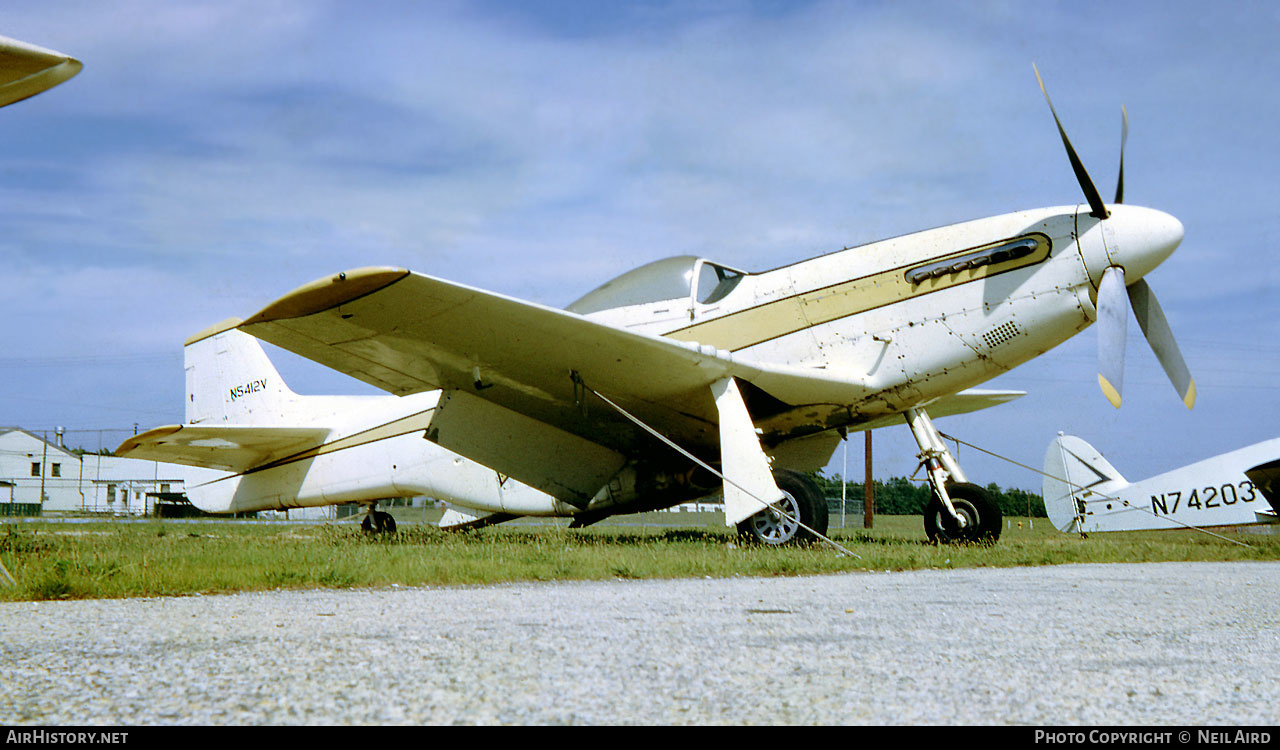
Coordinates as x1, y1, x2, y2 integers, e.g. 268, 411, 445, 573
666, 233, 1052, 352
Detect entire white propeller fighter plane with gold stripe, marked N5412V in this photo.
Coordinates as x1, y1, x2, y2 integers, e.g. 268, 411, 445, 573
118, 73, 1196, 544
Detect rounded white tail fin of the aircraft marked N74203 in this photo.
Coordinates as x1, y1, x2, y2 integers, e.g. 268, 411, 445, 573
1042, 434, 1129, 531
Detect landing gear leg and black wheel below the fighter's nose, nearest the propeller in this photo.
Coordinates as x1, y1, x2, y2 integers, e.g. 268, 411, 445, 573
906, 408, 1001, 543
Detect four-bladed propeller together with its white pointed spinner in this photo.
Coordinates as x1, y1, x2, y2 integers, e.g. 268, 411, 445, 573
1032, 64, 1196, 408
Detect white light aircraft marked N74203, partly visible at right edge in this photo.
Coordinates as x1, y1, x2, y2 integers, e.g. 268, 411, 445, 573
1043, 435, 1280, 534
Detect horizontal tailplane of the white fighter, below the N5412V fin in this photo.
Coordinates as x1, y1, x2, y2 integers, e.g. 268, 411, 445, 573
115, 425, 329, 472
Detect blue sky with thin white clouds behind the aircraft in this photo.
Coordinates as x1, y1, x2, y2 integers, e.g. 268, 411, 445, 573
0, 0, 1280, 489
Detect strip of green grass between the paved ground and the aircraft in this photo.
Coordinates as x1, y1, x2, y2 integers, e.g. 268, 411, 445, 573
0, 511, 1280, 600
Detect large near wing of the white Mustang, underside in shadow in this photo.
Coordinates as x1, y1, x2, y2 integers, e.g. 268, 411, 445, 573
239, 269, 868, 457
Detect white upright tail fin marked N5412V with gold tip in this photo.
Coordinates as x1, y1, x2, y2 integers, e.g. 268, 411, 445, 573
183, 319, 298, 425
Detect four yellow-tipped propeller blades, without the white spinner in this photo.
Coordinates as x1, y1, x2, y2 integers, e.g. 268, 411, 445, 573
1032, 64, 1196, 408
